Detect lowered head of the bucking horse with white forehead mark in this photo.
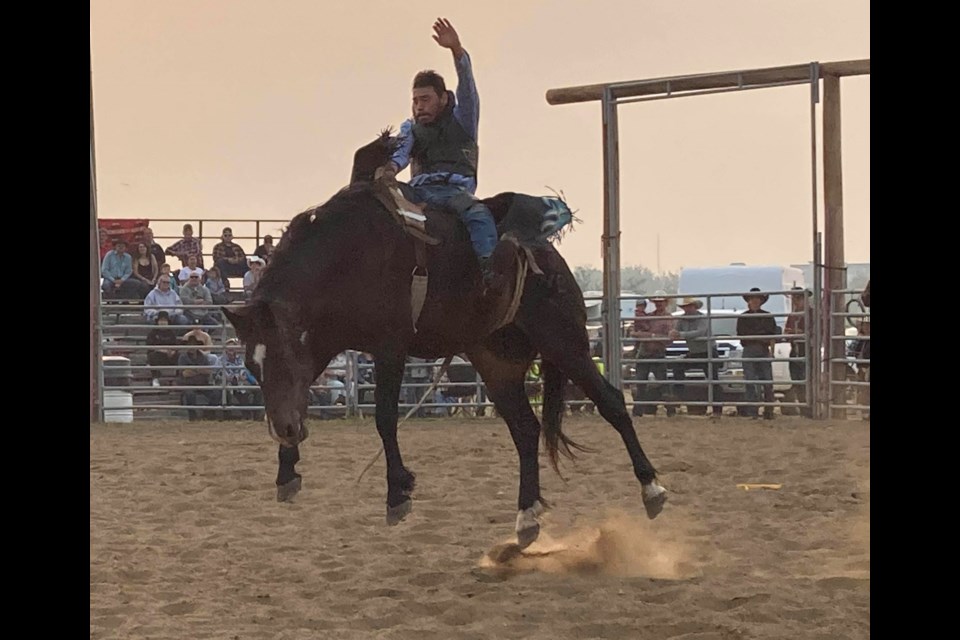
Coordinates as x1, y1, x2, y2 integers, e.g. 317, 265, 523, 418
222, 300, 313, 446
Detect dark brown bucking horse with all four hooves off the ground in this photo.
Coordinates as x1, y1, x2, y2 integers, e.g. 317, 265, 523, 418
223, 131, 667, 547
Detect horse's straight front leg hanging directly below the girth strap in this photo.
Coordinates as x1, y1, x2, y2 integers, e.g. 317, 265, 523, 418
374, 354, 415, 525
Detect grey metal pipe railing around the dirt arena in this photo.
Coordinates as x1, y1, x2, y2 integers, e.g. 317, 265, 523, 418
98, 290, 869, 417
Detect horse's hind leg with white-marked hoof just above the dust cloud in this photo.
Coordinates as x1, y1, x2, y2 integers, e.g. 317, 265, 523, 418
467, 342, 546, 549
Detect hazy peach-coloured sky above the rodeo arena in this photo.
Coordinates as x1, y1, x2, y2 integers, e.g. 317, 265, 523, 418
90, 0, 870, 271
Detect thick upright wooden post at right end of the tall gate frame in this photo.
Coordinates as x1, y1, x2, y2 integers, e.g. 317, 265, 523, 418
823, 74, 847, 419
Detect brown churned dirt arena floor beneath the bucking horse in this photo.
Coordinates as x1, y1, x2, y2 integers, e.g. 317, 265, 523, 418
90, 417, 870, 640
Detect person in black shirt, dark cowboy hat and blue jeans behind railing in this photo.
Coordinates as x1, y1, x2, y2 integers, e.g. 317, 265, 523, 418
737, 287, 780, 420
